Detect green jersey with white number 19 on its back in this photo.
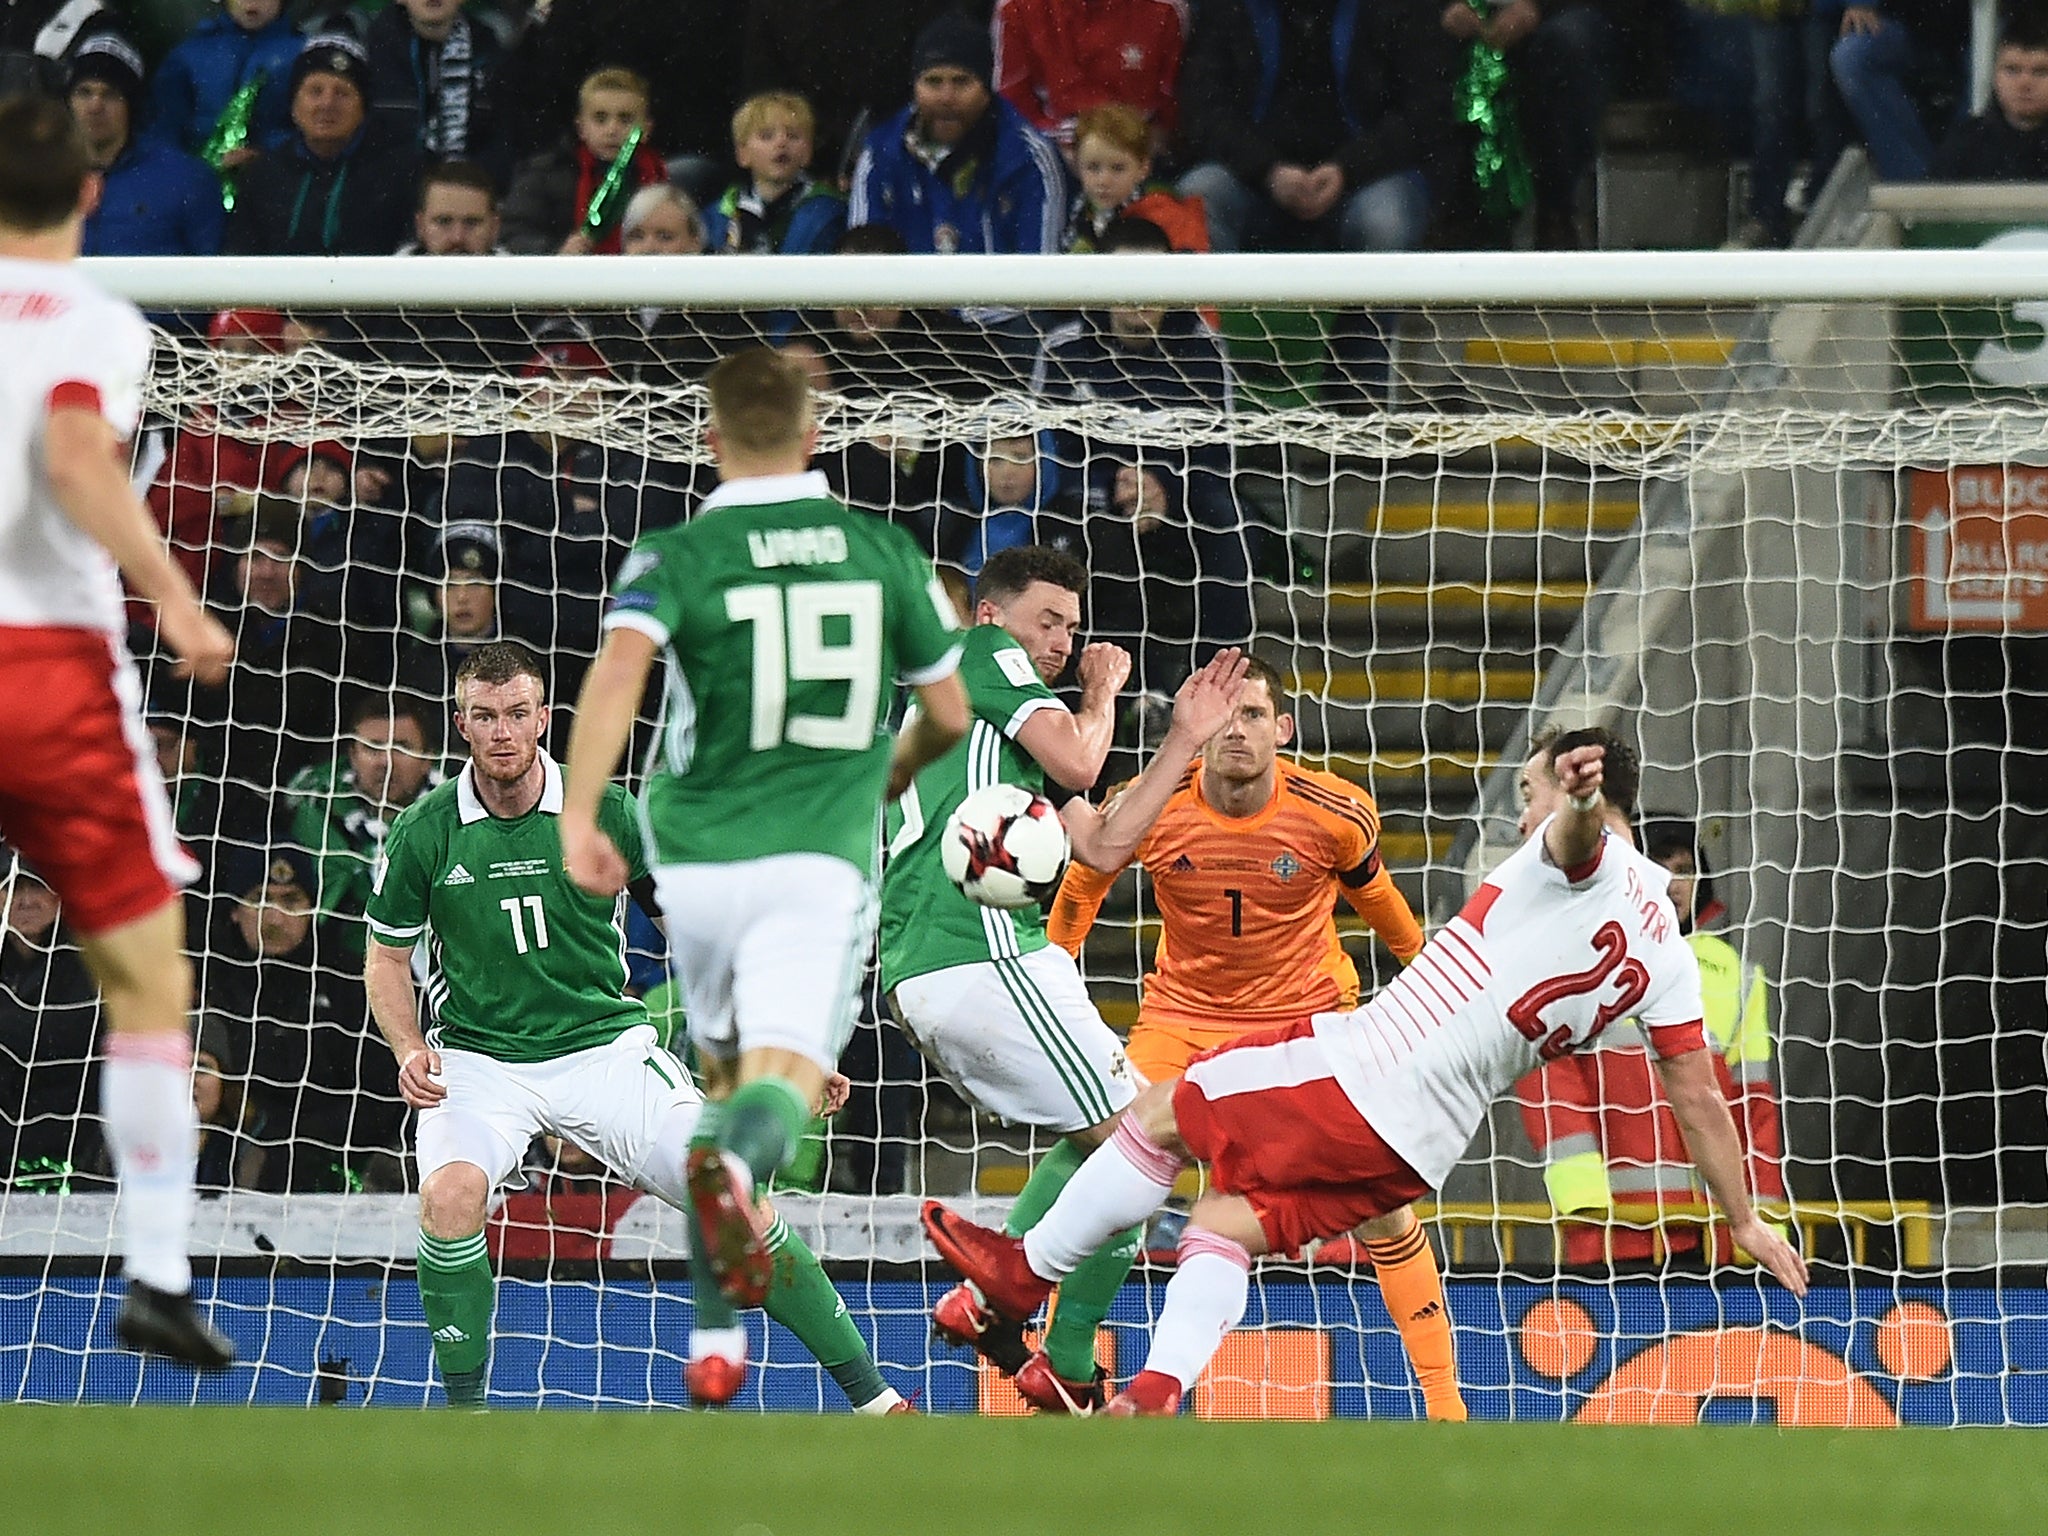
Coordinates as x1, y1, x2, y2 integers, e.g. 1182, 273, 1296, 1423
604, 471, 961, 879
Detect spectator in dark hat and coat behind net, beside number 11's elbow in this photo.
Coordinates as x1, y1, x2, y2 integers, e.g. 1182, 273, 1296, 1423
203, 850, 403, 1192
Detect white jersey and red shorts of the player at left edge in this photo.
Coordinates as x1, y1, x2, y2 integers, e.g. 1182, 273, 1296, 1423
0, 260, 199, 934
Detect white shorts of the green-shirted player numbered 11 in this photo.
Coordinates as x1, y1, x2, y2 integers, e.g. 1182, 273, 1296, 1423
418, 1024, 705, 1198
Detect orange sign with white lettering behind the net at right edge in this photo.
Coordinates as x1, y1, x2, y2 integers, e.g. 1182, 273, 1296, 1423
1907, 465, 2048, 635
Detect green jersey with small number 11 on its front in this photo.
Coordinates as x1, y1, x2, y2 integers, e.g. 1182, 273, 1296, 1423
369, 754, 647, 1061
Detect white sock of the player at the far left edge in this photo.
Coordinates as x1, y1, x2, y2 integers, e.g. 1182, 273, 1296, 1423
100, 1034, 199, 1296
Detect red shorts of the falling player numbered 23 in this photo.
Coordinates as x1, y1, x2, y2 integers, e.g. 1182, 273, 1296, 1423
1174, 1020, 1430, 1253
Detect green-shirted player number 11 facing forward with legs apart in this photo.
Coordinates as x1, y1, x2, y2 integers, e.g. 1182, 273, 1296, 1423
365, 643, 907, 1413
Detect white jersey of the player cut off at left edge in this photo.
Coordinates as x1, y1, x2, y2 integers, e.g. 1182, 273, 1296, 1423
0, 260, 150, 635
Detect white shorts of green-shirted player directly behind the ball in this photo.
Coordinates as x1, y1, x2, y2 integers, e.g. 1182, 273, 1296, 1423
889, 944, 1139, 1133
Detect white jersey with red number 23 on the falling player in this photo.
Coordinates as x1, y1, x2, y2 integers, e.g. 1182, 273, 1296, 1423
1315, 821, 1704, 1188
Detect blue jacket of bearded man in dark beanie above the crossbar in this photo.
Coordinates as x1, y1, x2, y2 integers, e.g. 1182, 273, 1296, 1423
846, 96, 1067, 256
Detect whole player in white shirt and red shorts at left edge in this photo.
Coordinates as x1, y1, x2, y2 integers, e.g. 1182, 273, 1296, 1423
0, 96, 233, 1368
